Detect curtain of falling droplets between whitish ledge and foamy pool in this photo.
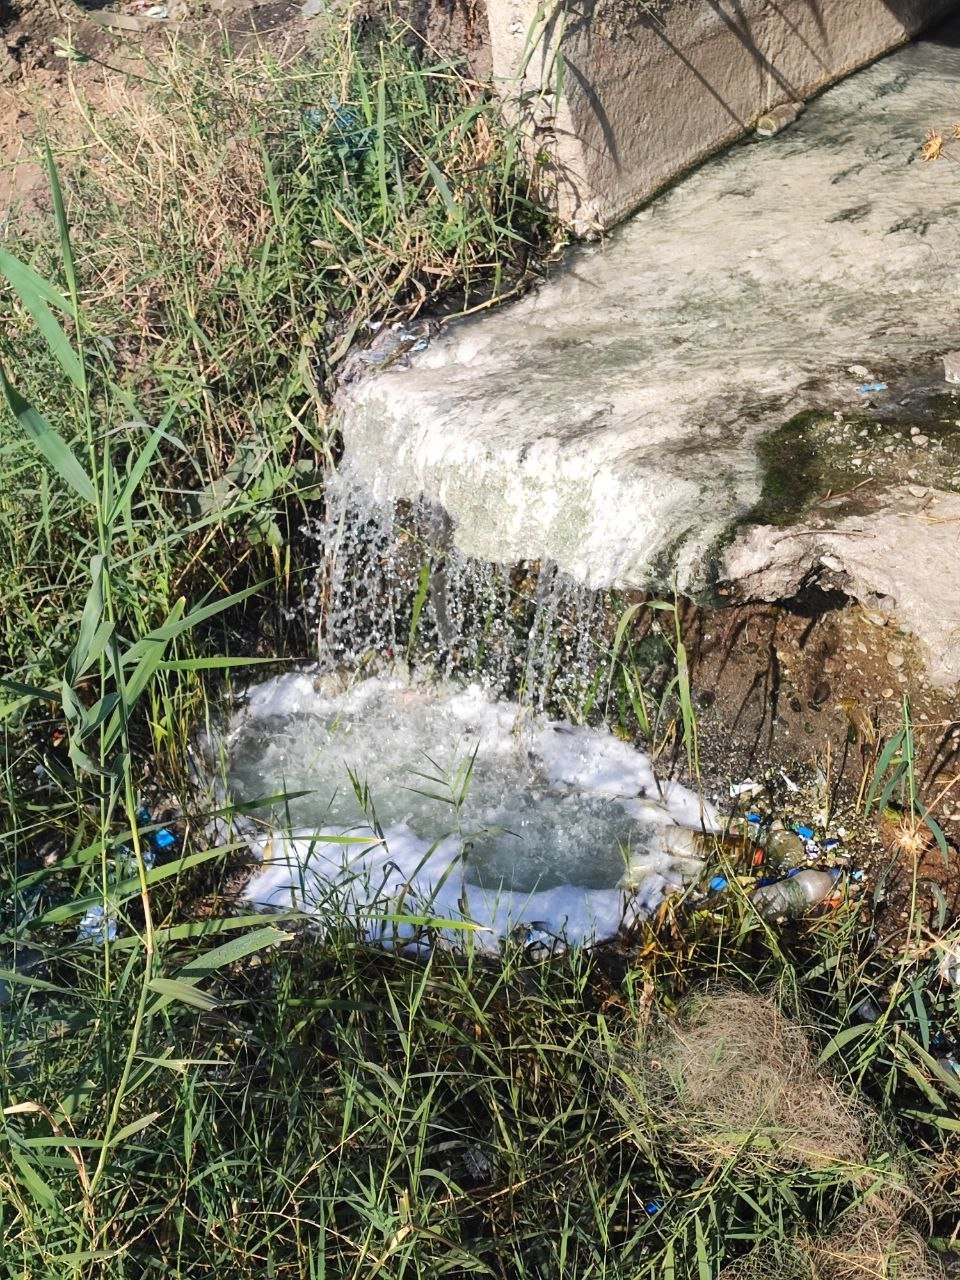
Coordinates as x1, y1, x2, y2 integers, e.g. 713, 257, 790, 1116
289, 471, 605, 713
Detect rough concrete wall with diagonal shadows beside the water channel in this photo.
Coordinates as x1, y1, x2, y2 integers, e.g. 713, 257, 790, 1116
486, 0, 957, 233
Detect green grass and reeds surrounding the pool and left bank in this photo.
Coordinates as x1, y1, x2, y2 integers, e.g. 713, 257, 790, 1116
0, 10, 960, 1280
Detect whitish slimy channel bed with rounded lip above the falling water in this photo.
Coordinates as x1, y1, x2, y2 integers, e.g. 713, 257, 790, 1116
342, 27, 960, 680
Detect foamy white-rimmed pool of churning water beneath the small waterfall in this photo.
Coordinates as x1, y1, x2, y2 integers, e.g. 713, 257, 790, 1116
216, 672, 716, 950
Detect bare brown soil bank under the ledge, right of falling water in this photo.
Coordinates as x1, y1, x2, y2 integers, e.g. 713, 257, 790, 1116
686, 593, 960, 945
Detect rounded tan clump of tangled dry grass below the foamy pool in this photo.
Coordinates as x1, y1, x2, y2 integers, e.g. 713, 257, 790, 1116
634, 995, 867, 1171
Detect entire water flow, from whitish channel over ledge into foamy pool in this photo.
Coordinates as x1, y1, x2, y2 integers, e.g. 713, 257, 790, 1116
220, 22, 960, 947
